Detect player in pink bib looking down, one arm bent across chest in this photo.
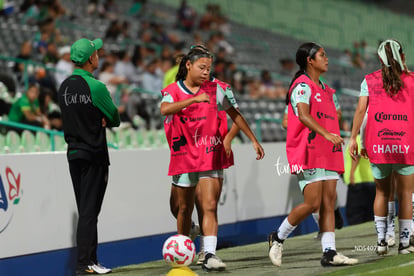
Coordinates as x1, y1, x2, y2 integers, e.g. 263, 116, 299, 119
160, 48, 264, 271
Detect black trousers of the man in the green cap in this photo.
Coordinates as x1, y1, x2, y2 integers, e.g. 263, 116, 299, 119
69, 159, 108, 268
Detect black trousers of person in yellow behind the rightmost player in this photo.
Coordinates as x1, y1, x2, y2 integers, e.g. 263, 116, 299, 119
346, 182, 375, 225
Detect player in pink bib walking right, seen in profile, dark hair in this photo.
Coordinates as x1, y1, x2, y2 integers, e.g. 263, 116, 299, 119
269, 42, 358, 266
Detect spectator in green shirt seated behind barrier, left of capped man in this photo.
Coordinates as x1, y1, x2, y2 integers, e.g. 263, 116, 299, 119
9, 78, 50, 129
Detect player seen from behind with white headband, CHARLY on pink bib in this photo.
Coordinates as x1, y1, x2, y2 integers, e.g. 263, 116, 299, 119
349, 39, 414, 255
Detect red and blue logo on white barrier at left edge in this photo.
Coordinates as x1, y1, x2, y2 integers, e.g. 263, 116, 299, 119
0, 167, 22, 233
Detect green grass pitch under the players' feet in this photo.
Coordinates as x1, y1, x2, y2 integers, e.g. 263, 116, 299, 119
113, 222, 414, 276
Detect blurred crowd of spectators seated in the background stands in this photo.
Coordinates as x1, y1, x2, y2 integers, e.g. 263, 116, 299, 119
0, 0, 376, 134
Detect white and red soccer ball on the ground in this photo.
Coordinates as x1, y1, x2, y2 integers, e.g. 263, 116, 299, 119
162, 234, 195, 267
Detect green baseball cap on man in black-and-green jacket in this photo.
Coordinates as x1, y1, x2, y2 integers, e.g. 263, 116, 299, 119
70, 38, 103, 65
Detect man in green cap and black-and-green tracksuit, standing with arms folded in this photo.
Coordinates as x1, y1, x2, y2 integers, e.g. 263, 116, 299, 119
58, 38, 120, 274
